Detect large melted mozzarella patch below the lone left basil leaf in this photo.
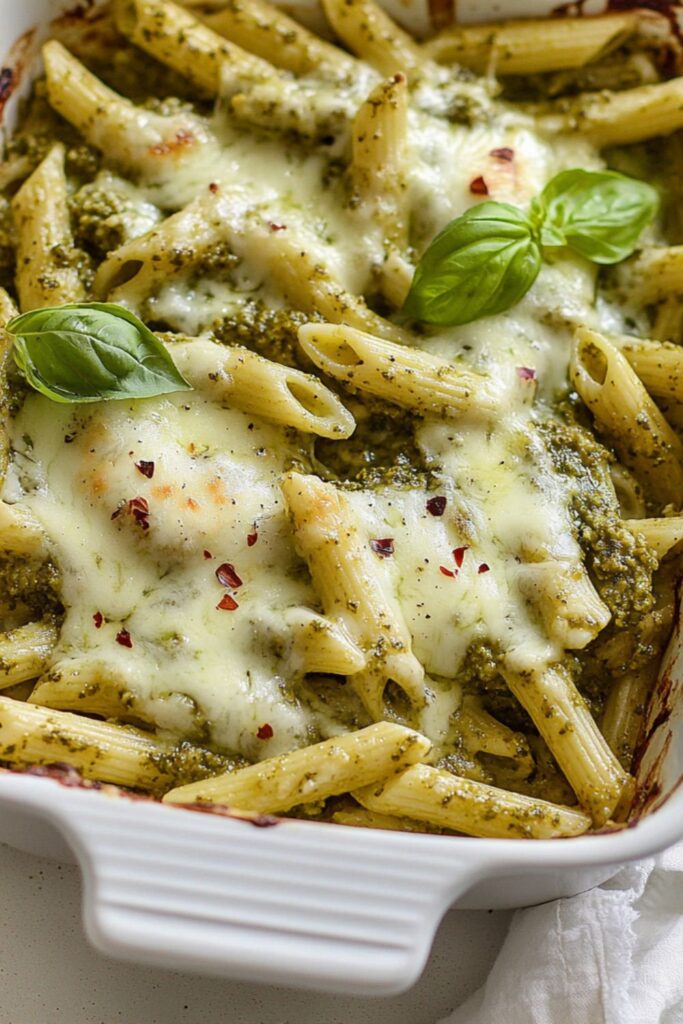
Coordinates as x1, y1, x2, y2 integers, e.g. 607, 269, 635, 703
10, 380, 325, 757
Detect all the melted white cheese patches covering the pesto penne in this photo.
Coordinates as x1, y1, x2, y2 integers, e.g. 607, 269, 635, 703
5, 37, 634, 759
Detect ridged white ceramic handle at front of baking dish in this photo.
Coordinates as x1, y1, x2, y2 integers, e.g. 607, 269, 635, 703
42, 793, 481, 995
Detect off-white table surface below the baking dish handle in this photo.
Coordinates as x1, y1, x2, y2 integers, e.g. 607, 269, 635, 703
0, 845, 512, 1024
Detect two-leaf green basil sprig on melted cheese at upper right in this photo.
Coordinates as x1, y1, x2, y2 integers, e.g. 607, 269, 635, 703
403, 169, 658, 327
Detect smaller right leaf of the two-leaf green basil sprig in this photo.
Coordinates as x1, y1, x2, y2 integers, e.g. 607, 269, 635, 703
539, 169, 659, 263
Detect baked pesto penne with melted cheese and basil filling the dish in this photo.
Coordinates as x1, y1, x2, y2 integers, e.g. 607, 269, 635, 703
0, 0, 683, 838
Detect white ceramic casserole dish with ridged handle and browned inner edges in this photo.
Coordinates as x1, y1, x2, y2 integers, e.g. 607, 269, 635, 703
0, 0, 683, 994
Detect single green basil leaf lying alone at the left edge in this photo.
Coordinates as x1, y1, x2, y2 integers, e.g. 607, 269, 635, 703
7, 302, 191, 402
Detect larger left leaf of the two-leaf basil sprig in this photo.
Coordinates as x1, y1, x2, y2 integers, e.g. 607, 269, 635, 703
403, 202, 541, 327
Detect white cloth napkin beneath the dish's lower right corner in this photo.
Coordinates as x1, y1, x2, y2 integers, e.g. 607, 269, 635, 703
441, 844, 683, 1024
